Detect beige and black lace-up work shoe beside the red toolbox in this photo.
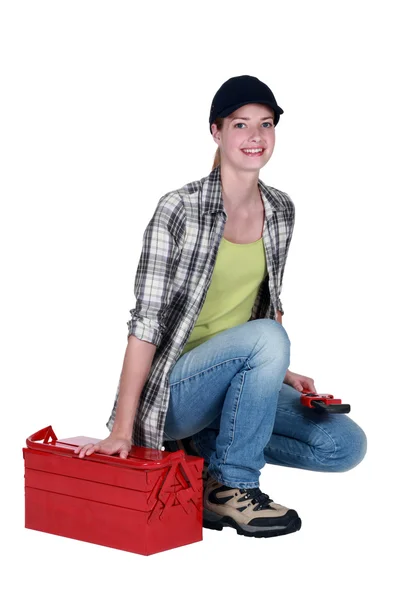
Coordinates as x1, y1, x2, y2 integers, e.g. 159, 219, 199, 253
203, 475, 301, 537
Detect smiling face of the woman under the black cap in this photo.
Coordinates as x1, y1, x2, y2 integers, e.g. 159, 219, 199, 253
211, 104, 275, 171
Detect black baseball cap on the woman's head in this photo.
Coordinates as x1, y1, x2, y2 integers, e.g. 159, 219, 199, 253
209, 75, 283, 133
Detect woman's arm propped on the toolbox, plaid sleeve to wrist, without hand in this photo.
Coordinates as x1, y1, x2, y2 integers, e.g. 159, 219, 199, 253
112, 195, 185, 439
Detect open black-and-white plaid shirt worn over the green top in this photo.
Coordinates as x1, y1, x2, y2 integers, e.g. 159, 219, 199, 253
107, 166, 295, 450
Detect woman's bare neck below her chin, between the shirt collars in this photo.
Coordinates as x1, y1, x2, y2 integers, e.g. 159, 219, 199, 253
220, 164, 261, 212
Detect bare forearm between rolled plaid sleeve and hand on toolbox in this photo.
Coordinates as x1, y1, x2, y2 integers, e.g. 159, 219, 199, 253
112, 335, 157, 439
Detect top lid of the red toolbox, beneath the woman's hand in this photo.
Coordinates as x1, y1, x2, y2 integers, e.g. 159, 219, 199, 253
26, 425, 186, 469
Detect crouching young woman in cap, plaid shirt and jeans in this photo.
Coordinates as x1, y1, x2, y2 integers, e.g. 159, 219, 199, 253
76, 75, 367, 537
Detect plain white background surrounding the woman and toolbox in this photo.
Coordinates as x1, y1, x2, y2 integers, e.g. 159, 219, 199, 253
0, 0, 400, 600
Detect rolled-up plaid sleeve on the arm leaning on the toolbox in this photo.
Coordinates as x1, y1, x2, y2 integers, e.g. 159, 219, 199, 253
127, 195, 185, 346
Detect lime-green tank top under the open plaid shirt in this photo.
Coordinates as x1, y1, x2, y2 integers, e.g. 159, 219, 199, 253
180, 237, 267, 356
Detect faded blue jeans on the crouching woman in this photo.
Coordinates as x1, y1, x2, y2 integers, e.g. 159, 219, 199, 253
164, 319, 367, 488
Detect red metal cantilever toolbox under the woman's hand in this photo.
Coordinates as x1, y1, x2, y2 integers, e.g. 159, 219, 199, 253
23, 426, 204, 556
